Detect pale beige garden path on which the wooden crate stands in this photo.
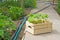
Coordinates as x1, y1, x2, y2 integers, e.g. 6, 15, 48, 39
24, 6, 60, 40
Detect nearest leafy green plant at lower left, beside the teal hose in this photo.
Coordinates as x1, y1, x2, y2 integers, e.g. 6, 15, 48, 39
0, 13, 16, 40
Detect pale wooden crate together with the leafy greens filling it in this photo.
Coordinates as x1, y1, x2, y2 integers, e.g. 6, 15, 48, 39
26, 13, 52, 34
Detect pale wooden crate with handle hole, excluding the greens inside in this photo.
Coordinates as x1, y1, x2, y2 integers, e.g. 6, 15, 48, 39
26, 21, 52, 34
